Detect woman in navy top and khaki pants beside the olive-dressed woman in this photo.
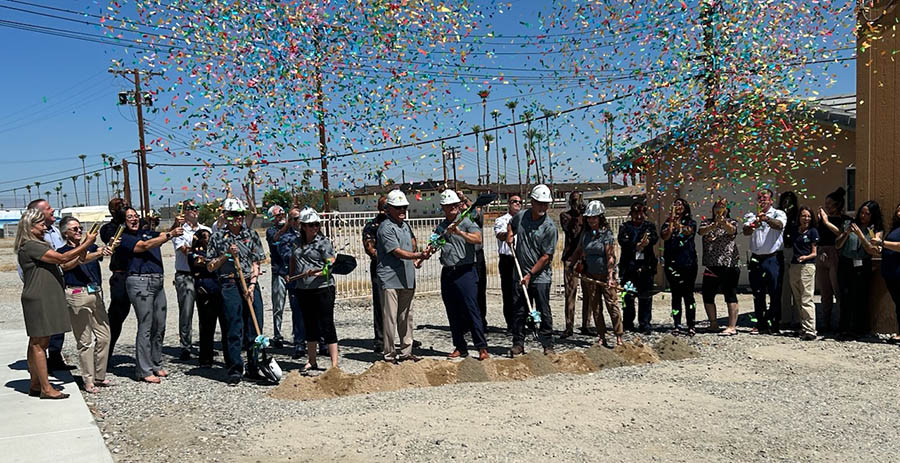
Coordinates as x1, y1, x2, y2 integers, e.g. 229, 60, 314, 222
56, 217, 112, 393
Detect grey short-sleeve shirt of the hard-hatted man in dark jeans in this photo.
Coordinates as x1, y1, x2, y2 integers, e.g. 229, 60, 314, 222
510, 209, 559, 283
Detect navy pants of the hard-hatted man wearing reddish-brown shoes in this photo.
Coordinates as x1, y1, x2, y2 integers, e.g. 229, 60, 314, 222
441, 265, 487, 353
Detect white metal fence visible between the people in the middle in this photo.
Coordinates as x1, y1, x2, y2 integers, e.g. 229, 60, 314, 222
312, 212, 627, 299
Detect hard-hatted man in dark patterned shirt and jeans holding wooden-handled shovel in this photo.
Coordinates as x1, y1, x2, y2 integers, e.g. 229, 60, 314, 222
206, 198, 266, 385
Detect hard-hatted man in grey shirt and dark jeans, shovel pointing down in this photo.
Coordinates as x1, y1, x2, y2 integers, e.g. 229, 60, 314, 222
506, 185, 557, 356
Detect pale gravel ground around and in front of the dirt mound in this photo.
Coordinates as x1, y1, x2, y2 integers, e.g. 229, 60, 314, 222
0, 246, 900, 462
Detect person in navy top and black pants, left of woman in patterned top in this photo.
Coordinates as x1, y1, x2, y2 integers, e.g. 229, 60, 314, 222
659, 198, 697, 336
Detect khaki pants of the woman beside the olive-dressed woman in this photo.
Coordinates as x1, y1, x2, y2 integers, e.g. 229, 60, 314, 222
66, 288, 109, 385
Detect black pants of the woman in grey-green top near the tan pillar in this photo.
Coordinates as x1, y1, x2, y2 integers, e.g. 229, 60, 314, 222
838, 256, 872, 334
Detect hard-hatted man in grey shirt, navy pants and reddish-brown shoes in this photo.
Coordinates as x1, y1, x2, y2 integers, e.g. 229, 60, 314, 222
438, 190, 490, 360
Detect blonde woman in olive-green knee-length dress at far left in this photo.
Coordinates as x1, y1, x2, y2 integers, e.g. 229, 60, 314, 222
13, 209, 97, 399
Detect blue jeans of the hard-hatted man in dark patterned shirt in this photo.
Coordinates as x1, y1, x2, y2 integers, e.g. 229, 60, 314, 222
222, 280, 263, 376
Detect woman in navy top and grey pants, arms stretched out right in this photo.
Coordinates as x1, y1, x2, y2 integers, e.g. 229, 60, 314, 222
116, 207, 184, 384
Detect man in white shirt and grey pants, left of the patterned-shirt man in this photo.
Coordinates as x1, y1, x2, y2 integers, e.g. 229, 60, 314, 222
172, 199, 211, 360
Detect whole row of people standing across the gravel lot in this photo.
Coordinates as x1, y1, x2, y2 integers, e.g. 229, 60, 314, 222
14, 185, 900, 399
